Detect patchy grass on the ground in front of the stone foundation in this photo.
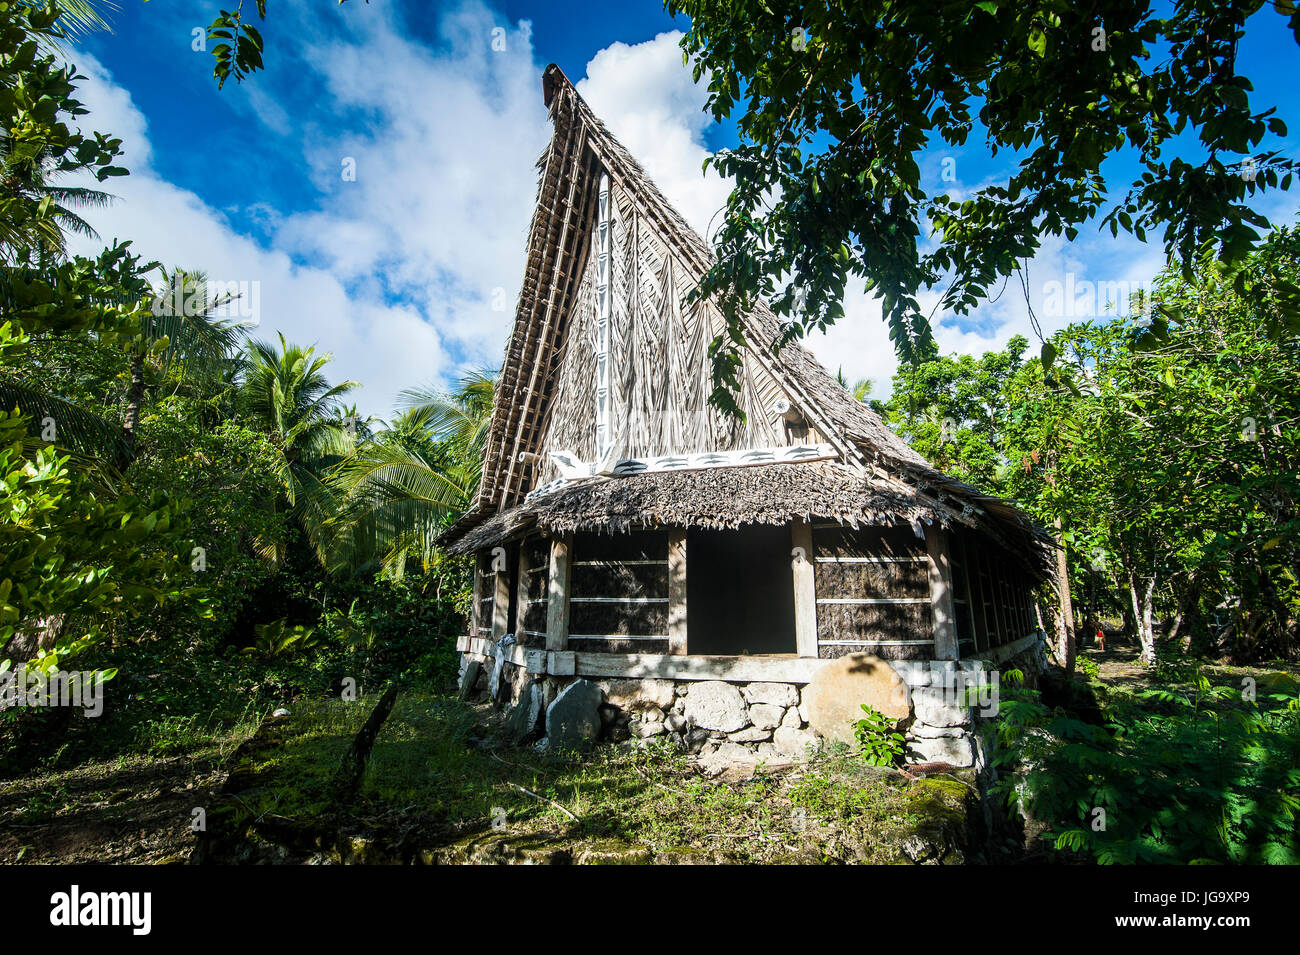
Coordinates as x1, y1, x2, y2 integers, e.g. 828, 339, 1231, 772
213, 691, 970, 863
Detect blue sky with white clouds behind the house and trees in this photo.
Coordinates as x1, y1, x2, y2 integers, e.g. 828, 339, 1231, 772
63, 0, 1300, 417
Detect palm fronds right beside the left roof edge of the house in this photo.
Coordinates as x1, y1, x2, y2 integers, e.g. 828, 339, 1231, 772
330, 372, 497, 577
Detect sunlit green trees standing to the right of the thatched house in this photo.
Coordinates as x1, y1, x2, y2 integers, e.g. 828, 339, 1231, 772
874, 229, 1300, 660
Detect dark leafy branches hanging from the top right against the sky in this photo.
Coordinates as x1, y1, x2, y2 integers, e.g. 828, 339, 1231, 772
666, 0, 1300, 407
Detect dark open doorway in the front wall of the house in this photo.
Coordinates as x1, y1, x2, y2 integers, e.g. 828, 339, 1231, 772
686, 525, 797, 655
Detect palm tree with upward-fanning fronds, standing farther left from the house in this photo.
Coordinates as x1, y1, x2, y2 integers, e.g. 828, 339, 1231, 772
239, 334, 359, 563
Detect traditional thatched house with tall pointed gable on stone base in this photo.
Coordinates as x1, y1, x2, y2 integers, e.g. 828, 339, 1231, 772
443, 66, 1043, 769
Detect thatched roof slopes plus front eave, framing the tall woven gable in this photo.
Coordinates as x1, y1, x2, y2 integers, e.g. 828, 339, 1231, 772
443, 65, 1045, 574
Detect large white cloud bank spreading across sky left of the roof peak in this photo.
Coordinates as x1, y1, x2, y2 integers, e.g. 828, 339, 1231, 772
63, 3, 559, 416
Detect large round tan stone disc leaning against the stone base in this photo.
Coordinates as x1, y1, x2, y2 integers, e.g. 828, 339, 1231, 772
803, 654, 911, 746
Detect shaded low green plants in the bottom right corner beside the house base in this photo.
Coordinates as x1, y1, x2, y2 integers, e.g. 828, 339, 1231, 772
997, 668, 1300, 864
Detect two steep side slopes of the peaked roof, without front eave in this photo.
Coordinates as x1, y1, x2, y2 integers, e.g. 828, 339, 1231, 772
443, 64, 1039, 574
